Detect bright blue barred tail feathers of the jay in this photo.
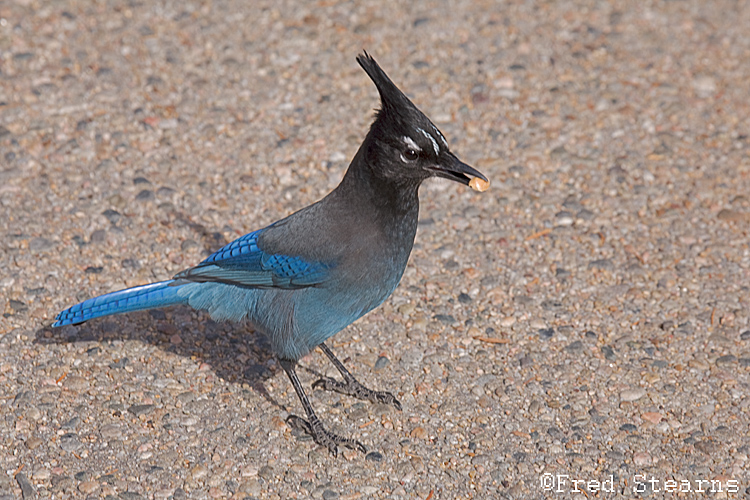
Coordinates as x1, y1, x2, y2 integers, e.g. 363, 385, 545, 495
52, 280, 185, 327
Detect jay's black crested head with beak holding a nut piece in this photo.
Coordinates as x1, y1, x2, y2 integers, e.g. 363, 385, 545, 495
357, 52, 489, 191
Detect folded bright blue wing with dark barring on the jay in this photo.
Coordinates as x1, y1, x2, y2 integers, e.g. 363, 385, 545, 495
175, 229, 332, 288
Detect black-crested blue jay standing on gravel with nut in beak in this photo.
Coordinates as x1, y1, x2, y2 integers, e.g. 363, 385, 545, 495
52, 51, 489, 456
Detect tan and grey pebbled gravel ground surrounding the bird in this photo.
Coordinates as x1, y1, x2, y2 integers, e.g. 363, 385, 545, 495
0, 0, 750, 500
